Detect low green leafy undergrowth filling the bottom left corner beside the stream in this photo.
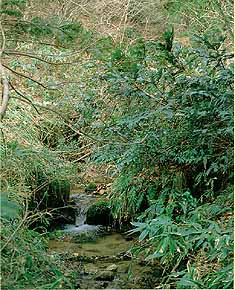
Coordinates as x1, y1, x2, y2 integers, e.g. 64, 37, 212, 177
1, 218, 73, 290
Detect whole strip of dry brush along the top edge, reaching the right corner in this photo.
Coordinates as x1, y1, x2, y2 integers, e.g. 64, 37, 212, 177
22, 0, 233, 45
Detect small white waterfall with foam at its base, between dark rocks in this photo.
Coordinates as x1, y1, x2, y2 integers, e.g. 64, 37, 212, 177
64, 194, 99, 232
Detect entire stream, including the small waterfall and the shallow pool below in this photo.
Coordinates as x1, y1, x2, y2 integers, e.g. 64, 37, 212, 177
49, 194, 160, 289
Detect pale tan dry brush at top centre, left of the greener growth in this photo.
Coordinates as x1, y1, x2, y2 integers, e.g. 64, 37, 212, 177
26, 0, 168, 41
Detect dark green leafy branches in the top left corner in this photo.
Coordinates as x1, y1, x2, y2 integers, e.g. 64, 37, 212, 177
0, 0, 88, 45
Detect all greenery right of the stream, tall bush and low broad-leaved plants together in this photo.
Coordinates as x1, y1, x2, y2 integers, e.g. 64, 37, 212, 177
88, 30, 233, 288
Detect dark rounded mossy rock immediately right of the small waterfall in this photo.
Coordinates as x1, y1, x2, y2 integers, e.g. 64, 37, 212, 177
86, 201, 113, 226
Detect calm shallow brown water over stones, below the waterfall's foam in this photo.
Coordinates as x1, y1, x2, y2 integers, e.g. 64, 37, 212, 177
49, 233, 156, 289
